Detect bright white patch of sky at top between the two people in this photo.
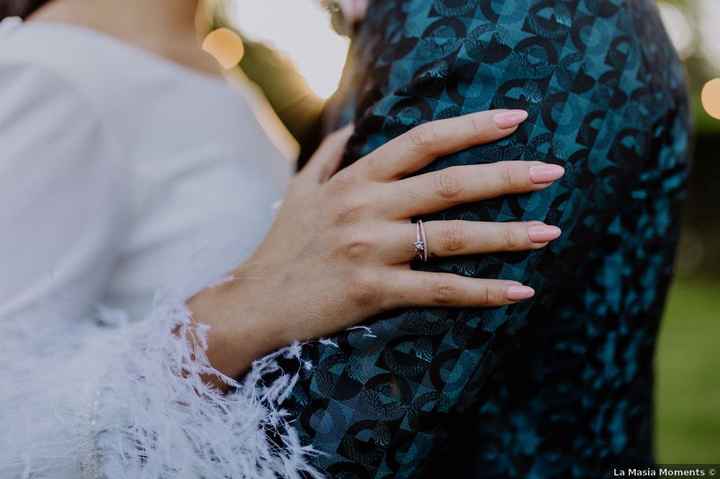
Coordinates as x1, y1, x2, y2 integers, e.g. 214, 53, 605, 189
230, 0, 349, 98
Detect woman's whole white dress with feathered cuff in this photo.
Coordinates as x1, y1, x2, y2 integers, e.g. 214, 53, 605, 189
0, 19, 318, 479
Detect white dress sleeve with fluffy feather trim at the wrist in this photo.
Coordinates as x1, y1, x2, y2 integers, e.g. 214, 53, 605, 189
0, 62, 314, 479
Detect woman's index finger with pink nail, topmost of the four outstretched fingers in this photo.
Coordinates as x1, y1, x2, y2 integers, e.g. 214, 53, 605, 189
363, 110, 528, 181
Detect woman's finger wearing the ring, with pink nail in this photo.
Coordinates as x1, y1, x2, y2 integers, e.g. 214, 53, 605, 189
380, 220, 562, 264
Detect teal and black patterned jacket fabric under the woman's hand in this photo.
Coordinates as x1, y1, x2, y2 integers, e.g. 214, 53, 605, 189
284, 0, 689, 479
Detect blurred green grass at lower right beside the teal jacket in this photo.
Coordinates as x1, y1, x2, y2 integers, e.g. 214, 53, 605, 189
656, 280, 720, 464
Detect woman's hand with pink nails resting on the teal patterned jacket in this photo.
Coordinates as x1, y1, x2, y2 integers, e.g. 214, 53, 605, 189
190, 111, 564, 374
